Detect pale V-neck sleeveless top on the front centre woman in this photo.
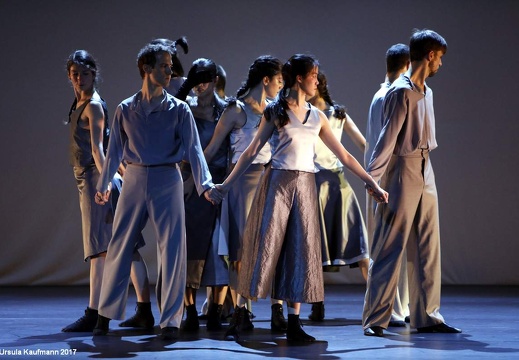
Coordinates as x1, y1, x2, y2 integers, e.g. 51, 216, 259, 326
271, 104, 321, 173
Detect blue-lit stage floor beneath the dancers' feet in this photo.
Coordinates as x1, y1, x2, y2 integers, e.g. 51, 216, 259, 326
0, 285, 519, 360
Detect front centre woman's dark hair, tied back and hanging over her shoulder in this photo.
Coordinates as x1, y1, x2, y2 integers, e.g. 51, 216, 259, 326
264, 54, 319, 127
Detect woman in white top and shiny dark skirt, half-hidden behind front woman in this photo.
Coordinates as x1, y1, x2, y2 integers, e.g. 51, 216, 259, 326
308, 72, 369, 321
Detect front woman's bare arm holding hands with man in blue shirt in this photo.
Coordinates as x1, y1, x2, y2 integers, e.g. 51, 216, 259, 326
216, 116, 276, 195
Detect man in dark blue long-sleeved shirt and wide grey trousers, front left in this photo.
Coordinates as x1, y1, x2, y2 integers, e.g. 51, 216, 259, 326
94, 43, 221, 340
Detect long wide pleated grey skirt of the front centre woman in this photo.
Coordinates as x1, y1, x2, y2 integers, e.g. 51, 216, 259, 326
238, 168, 324, 303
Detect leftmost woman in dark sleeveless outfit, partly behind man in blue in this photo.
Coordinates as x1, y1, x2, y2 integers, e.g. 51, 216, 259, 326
62, 50, 155, 332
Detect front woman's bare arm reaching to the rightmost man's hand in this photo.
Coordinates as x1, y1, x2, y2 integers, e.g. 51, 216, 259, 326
319, 113, 388, 202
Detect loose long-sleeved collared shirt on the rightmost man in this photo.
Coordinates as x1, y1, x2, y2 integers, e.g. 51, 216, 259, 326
367, 74, 438, 181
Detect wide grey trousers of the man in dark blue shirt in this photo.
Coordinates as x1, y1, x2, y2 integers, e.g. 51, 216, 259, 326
99, 165, 186, 328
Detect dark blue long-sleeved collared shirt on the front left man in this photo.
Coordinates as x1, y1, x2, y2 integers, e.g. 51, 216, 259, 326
97, 90, 213, 194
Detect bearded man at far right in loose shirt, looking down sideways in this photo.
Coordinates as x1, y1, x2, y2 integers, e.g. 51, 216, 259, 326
362, 29, 461, 336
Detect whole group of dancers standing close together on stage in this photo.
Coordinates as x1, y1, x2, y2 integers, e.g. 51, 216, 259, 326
63, 30, 460, 342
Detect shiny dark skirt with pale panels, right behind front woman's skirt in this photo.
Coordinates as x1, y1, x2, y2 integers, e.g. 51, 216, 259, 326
315, 168, 369, 266
